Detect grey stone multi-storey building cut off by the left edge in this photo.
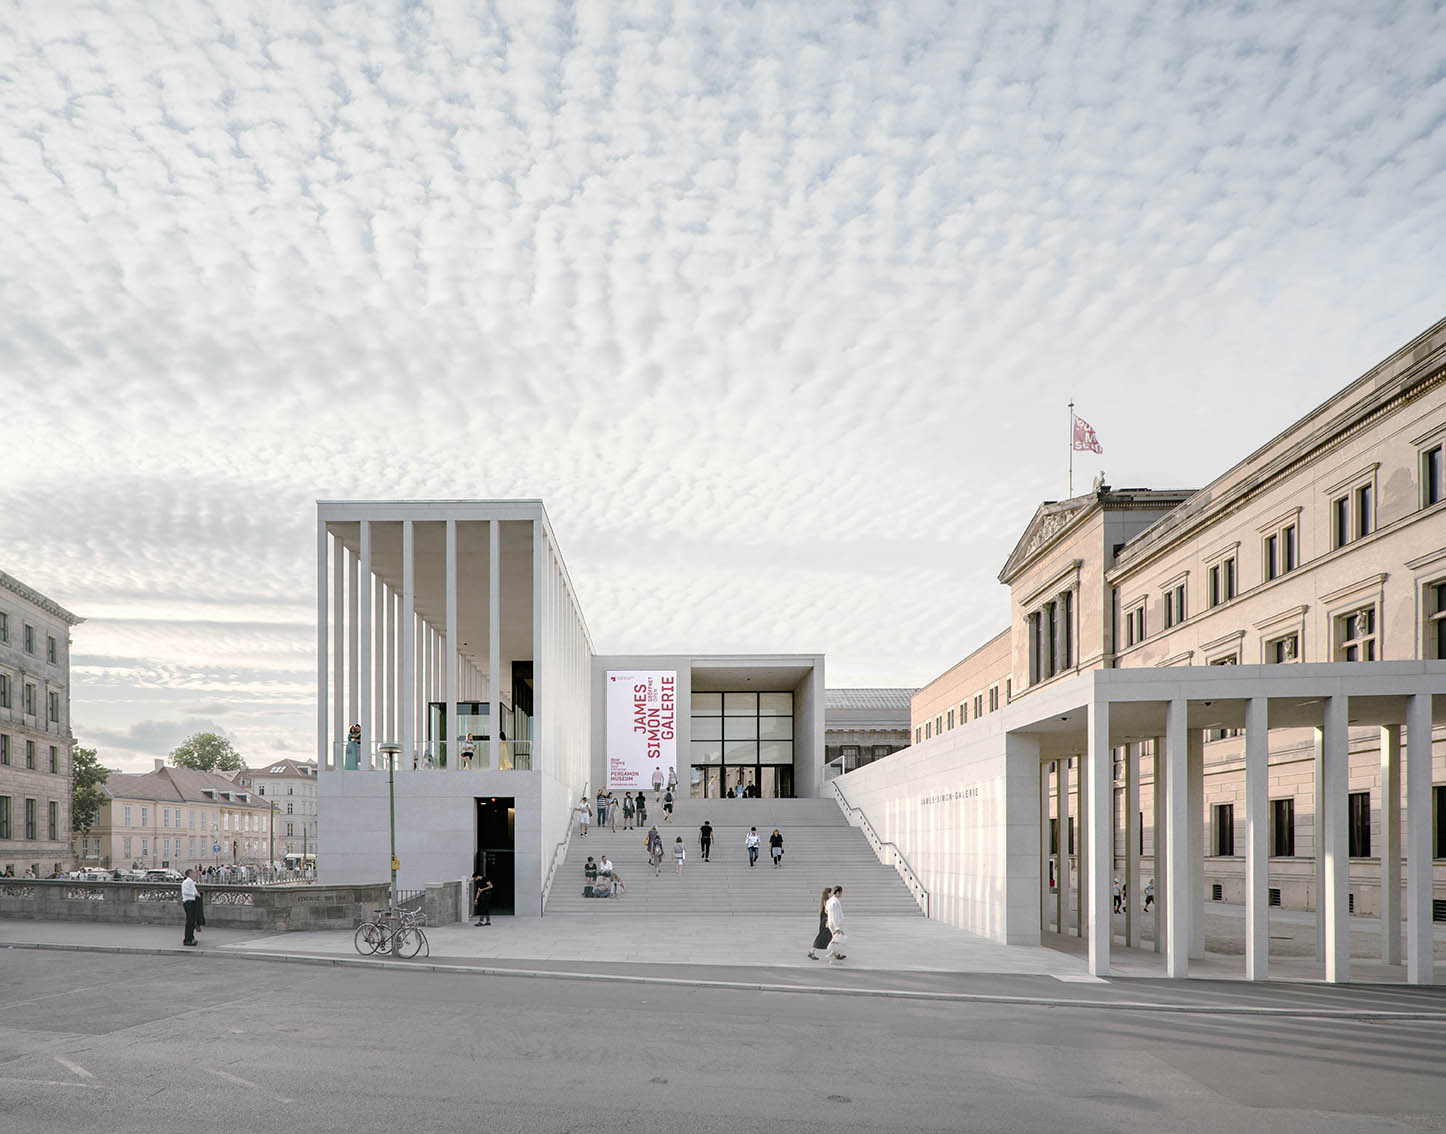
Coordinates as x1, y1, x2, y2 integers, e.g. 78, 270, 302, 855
0, 571, 84, 875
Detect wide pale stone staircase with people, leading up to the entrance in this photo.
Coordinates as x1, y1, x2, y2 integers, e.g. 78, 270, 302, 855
547, 793, 920, 917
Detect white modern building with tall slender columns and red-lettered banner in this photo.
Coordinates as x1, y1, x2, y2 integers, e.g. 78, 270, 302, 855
317, 500, 824, 916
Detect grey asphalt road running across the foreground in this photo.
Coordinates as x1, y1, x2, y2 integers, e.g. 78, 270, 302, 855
0, 950, 1446, 1134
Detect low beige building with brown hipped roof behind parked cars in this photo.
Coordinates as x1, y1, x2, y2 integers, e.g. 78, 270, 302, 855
75, 759, 281, 869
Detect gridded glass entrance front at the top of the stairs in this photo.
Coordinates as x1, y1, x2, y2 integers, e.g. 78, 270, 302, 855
688, 691, 794, 798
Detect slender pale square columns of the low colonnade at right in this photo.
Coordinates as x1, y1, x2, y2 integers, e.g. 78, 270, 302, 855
1040, 693, 1433, 984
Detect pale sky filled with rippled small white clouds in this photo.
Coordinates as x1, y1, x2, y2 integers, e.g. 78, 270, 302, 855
0, 0, 1446, 767
